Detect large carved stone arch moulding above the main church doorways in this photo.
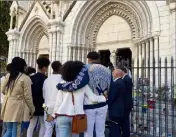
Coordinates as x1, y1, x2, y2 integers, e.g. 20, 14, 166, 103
72, 1, 152, 50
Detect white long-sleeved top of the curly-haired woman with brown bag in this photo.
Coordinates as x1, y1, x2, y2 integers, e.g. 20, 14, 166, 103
52, 85, 106, 117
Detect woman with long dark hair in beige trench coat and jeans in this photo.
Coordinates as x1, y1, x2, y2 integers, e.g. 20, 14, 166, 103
1, 57, 35, 137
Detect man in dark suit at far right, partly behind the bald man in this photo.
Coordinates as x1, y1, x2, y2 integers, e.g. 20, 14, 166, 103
120, 67, 133, 137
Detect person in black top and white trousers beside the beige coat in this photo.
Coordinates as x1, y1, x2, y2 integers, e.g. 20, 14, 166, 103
27, 57, 50, 137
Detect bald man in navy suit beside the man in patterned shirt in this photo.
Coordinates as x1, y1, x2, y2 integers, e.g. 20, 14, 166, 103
108, 69, 126, 137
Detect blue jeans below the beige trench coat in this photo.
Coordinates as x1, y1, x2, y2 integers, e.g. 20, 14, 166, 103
3, 122, 21, 137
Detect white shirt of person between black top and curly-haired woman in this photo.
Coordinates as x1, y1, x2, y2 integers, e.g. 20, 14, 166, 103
43, 74, 62, 113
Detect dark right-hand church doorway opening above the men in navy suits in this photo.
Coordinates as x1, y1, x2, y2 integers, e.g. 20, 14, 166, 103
116, 48, 132, 68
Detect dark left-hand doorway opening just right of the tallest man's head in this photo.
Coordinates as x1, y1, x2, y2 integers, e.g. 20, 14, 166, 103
99, 50, 111, 67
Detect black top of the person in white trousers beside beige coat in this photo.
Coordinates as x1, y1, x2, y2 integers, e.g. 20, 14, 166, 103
31, 72, 47, 116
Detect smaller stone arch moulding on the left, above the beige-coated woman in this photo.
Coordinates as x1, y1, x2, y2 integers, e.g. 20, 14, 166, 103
18, 16, 49, 67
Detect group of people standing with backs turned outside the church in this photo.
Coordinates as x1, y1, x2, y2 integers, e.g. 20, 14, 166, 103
1, 51, 133, 137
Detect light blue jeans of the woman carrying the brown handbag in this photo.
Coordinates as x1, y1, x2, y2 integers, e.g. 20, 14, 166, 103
56, 116, 79, 137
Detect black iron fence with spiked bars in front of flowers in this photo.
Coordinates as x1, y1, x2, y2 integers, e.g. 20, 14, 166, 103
125, 58, 176, 137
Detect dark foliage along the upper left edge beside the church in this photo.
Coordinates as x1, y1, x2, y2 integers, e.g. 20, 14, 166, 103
0, 1, 12, 57
